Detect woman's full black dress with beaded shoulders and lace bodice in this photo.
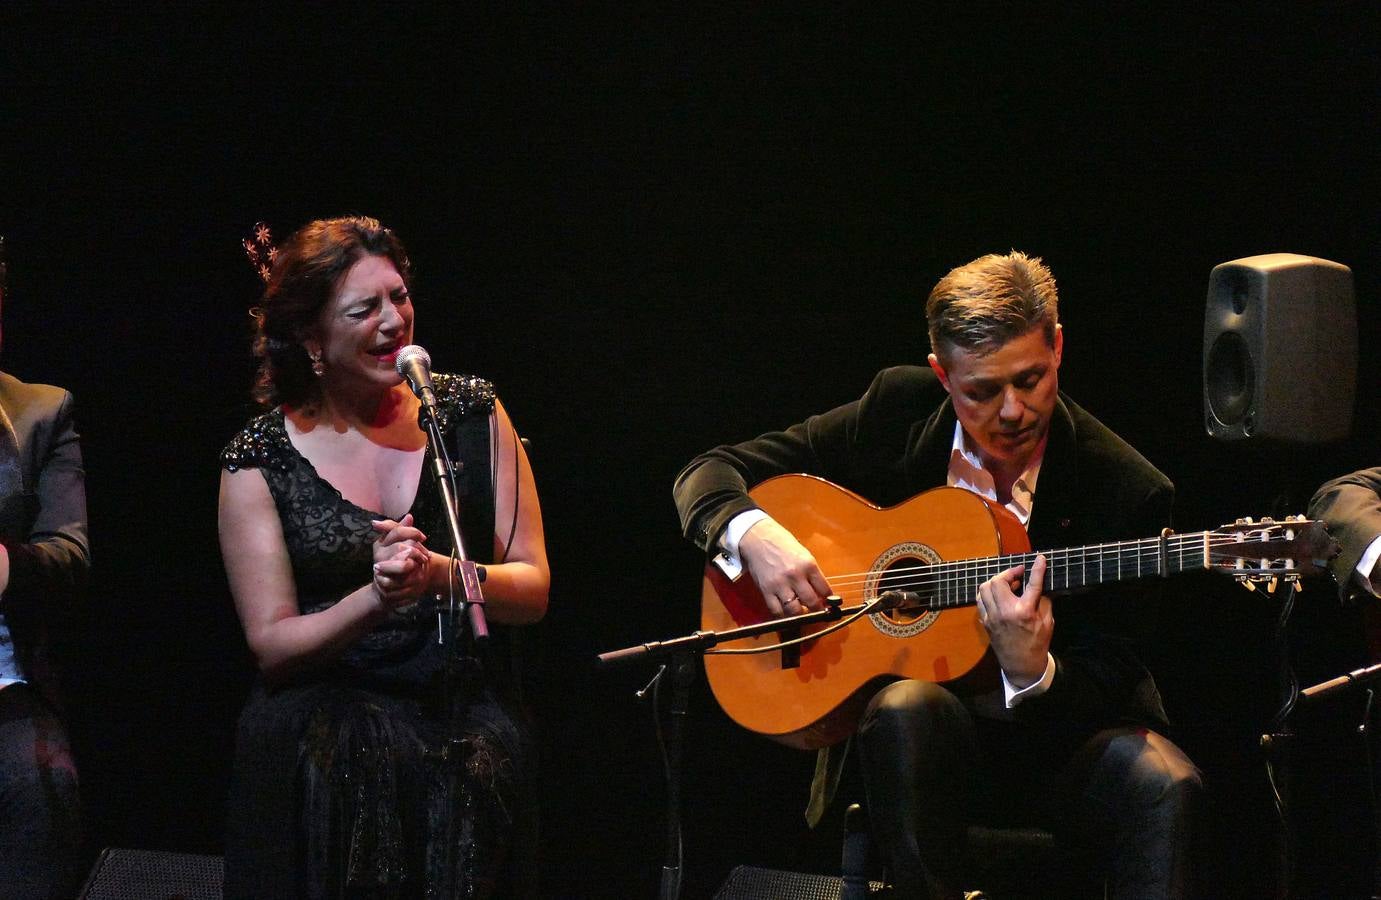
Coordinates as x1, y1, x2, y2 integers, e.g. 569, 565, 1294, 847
221, 375, 536, 900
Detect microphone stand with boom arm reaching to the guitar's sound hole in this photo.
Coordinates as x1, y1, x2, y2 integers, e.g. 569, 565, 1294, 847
598, 591, 889, 900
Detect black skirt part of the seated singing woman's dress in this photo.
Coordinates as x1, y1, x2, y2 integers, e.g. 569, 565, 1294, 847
225, 676, 537, 900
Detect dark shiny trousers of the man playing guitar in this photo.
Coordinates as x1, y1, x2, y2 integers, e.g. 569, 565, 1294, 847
858, 681, 1201, 900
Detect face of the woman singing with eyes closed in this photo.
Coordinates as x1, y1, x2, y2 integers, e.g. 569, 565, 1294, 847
307, 255, 413, 388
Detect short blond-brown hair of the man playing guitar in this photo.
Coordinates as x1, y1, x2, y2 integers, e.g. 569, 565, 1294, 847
925, 250, 1059, 360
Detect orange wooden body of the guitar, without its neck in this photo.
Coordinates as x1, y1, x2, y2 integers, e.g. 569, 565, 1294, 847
700, 475, 1030, 750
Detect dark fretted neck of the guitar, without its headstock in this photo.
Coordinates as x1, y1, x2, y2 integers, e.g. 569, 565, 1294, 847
916, 531, 1214, 609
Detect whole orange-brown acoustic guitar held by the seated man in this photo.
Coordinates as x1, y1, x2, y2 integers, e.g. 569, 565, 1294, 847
700, 475, 1335, 750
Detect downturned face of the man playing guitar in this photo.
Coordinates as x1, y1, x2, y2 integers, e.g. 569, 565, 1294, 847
929, 326, 1065, 473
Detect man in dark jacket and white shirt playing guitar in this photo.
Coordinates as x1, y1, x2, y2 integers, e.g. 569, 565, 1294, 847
674, 251, 1200, 897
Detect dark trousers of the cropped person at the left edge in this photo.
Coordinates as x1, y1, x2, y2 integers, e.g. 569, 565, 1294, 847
0, 685, 81, 900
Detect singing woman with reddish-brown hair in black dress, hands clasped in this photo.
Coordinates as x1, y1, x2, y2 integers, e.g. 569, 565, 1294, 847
220, 218, 550, 897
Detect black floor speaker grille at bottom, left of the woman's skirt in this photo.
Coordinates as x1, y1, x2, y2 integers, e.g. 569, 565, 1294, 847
79, 848, 225, 900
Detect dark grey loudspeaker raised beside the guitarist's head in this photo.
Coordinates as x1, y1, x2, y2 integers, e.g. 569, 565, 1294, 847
1203, 253, 1358, 443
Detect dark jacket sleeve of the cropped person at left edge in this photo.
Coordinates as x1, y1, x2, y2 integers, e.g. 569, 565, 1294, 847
4, 392, 90, 603
